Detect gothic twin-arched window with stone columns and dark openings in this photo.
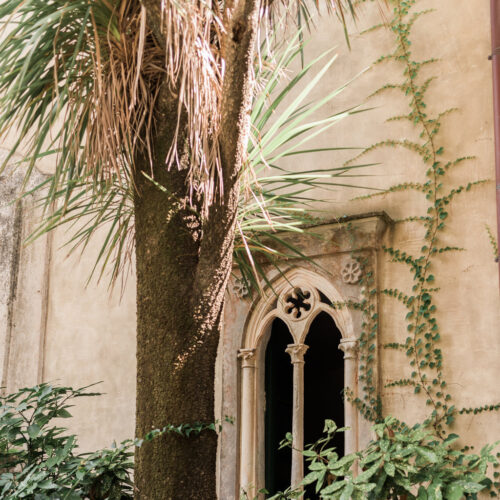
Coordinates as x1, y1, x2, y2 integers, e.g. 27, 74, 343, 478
239, 269, 357, 498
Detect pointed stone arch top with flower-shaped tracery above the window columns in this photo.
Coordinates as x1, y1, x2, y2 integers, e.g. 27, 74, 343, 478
242, 267, 354, 349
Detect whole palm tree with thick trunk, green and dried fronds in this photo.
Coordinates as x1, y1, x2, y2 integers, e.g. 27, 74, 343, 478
0, 0, 372, 500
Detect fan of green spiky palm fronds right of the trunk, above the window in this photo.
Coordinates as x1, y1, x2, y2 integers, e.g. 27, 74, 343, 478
234, 37, 372, 291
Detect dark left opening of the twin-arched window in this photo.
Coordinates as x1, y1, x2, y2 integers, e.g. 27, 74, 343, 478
265, 319, 293, 496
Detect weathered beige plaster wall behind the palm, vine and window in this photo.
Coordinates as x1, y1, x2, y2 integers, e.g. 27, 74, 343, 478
0, 0, 500, 492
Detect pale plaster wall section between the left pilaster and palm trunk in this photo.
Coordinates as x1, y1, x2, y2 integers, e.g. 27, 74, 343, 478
43, 225, 135, 449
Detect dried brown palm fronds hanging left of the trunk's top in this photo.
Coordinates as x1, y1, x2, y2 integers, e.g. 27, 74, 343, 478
83, 0, 165, 181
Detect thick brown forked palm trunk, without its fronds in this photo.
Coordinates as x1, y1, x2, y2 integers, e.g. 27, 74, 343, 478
135, 0, 260, 500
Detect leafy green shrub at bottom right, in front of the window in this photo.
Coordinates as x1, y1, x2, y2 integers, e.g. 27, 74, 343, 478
272, 417, 498, 500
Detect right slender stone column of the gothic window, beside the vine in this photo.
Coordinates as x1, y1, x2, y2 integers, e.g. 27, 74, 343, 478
339, 338, 358, 455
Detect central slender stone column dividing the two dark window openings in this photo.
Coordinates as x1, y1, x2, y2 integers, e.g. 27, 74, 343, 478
286, 344, 308, 487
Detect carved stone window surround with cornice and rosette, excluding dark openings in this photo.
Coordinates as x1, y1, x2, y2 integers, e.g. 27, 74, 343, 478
226, 213, 392, 500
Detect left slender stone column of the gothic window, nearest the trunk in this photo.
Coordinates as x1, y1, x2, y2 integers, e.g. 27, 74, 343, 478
238, 349, 257, 498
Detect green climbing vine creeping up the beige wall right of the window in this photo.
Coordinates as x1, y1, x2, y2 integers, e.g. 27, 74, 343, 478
346, 0, 500, 438
